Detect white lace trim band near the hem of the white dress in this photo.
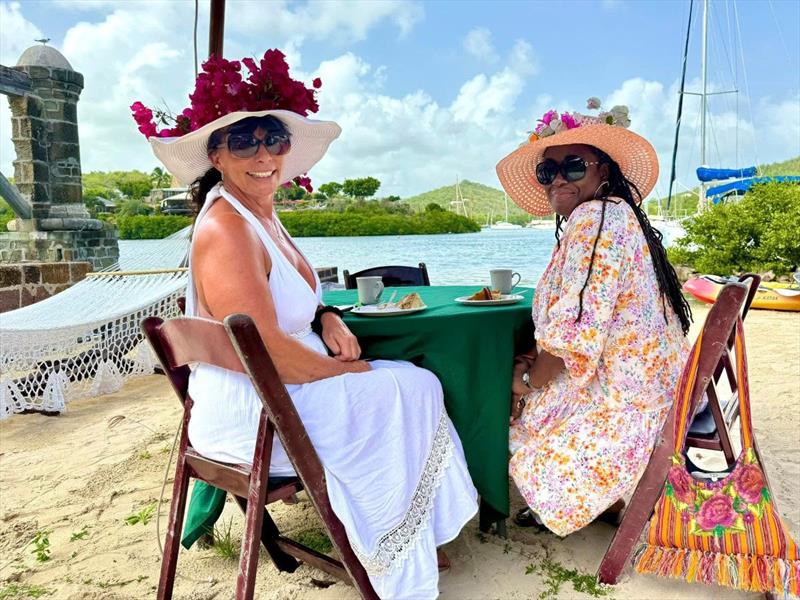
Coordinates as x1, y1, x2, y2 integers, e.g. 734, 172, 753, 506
351, 410, 454, 576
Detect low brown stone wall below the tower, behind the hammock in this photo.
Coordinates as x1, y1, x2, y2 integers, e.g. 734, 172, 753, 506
0, 261, 92, 312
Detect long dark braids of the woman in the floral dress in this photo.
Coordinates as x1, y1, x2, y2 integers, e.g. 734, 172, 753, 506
556, 146, 692, 335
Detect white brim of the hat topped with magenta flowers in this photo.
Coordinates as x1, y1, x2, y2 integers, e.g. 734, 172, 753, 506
148, 110, 342, 186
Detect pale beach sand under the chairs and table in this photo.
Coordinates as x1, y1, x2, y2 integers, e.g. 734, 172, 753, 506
0, 307, 800, 600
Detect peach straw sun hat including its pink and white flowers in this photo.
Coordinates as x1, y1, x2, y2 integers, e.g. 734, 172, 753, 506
496, 98, 658, 216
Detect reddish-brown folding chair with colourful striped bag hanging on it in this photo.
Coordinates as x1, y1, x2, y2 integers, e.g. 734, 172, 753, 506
597, 283, 766, 585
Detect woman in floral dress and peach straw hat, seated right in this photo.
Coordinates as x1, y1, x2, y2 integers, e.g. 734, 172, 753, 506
497, 99, 691, 536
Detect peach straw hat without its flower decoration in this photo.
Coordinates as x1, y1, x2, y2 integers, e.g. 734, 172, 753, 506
496, 117, 658, 217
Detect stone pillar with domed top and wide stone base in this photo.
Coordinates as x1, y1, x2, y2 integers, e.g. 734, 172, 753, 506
0, 45, 119, 270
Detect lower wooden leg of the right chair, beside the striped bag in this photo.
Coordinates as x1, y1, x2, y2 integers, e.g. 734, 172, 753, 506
597, 432, 673, 585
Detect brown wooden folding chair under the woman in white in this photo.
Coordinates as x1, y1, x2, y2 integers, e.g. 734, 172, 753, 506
142, 314, 378, 600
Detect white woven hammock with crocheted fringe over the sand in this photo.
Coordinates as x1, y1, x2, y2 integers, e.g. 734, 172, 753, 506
0, 230, 188, 419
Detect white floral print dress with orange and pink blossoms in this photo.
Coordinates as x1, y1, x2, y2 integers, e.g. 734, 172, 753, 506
509, 198, 689, 535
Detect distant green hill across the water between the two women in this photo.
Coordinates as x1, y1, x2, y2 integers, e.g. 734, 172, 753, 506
404, 179, 531, 225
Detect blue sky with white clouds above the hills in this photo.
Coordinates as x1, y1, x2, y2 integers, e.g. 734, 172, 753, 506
0, 0, 800, 198
